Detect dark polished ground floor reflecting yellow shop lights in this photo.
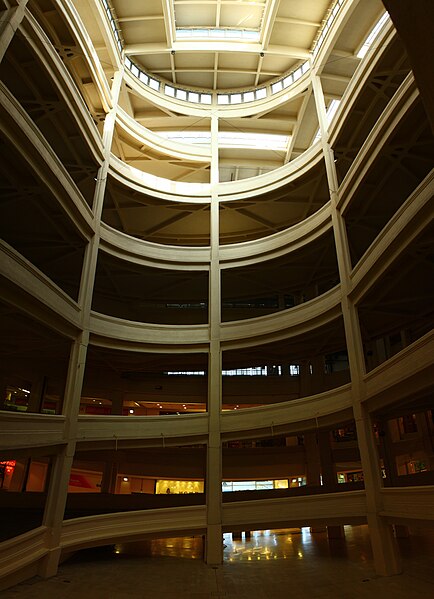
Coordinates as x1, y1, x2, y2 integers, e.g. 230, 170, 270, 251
1, 526, 434, 599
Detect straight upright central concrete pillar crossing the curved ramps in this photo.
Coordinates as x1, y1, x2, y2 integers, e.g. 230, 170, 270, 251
205, 114, 223, 565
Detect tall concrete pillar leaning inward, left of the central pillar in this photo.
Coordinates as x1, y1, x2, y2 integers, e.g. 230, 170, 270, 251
39, 66, 124, 578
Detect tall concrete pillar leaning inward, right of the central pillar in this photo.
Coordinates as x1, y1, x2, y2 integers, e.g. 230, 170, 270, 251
311, 73, 401, 576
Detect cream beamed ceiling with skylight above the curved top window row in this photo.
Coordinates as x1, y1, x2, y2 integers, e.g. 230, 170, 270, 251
112, 0, 334, 90
